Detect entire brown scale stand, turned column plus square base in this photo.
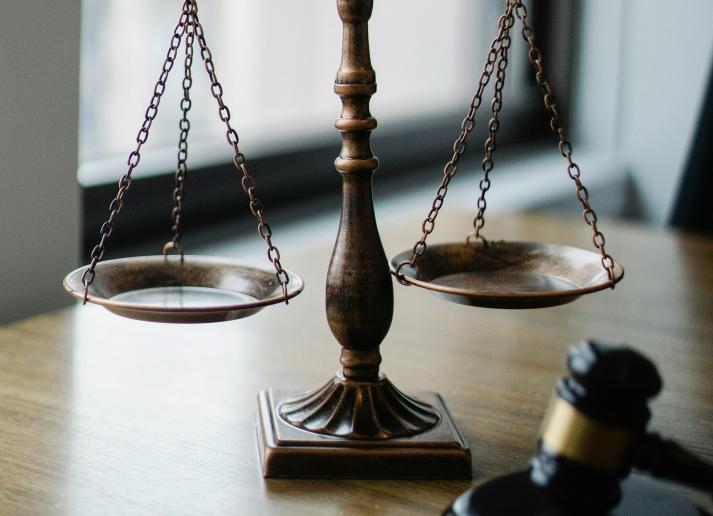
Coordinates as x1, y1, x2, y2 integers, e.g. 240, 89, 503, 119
257, 0, 472, 478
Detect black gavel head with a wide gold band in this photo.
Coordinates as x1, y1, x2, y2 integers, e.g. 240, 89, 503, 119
531, 341, 662, 514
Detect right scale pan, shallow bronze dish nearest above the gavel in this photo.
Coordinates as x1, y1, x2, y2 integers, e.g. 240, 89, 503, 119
391, 241, 624, 308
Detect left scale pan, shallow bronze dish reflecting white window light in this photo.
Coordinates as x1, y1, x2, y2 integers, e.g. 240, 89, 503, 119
64, 255, 304, 323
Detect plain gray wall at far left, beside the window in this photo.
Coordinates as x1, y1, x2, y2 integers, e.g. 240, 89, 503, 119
0, 0, 81, 323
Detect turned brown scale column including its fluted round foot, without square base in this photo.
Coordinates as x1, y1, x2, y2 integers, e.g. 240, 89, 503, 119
279, 0, 440, 439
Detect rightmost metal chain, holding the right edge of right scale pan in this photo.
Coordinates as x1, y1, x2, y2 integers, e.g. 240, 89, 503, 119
514, 0, 615, 288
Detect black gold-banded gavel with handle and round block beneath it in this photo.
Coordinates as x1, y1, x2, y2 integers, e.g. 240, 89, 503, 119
445, 341, 713, 516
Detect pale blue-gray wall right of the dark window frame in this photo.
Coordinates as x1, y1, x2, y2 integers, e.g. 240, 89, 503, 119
574, 0, 713, 225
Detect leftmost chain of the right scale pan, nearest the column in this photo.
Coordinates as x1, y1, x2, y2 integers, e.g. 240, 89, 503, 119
395, 0, 514, 285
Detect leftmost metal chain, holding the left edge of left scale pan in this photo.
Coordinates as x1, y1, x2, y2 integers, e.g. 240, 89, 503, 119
82, 0, 194, 304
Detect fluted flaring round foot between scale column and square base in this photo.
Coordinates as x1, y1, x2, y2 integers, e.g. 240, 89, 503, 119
278, 375, 440, 439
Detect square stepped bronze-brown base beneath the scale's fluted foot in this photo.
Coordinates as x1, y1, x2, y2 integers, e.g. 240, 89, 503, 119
257, 389, 472, 479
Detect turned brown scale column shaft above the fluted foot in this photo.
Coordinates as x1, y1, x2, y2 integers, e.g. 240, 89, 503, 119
326, 0, 394, 380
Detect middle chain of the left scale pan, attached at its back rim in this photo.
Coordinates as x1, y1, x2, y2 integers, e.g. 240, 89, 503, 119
163, 14, 195, 261
